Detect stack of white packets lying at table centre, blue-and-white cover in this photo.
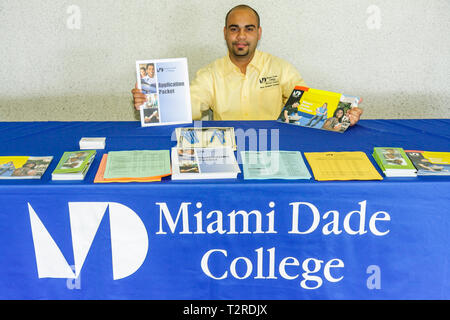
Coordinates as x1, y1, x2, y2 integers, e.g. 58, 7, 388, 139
172, 147, 241, 180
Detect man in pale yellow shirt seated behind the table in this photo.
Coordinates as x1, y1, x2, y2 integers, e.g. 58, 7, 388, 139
132, 5, 362, 124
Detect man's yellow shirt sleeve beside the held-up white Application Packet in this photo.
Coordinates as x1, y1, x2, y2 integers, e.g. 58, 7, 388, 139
190, 68, 214, 120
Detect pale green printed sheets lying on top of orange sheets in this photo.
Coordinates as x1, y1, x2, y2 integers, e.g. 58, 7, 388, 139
94, 150, 171, 183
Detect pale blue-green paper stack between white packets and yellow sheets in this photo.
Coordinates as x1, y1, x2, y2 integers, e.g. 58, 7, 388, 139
241, 151, 311, 179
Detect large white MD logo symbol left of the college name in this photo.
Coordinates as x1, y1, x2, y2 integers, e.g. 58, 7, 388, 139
28, 202, 148, 280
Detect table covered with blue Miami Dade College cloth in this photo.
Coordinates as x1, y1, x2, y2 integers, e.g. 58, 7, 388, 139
0, 119, 450, 300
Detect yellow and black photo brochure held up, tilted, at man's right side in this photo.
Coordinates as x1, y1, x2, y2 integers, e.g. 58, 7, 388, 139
277, 86, 361, 133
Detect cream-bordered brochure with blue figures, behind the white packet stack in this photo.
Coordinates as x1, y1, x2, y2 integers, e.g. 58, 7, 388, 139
175, 127, 236, 151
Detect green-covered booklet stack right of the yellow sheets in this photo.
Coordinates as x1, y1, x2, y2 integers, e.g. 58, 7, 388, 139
372, 147, 417, 177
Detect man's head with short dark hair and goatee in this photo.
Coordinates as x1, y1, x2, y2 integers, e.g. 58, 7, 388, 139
223, 9, 261, 58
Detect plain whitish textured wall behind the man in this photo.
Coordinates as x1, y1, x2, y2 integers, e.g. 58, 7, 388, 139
0, 0, 450, 121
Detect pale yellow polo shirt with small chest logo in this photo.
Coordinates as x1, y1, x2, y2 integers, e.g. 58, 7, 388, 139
190, 50, 306, 120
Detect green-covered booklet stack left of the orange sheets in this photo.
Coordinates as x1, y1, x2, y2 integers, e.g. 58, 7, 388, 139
52, 150, 97, 180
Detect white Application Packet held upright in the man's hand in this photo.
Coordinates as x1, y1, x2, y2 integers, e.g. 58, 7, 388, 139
136, 58, 192, 127
